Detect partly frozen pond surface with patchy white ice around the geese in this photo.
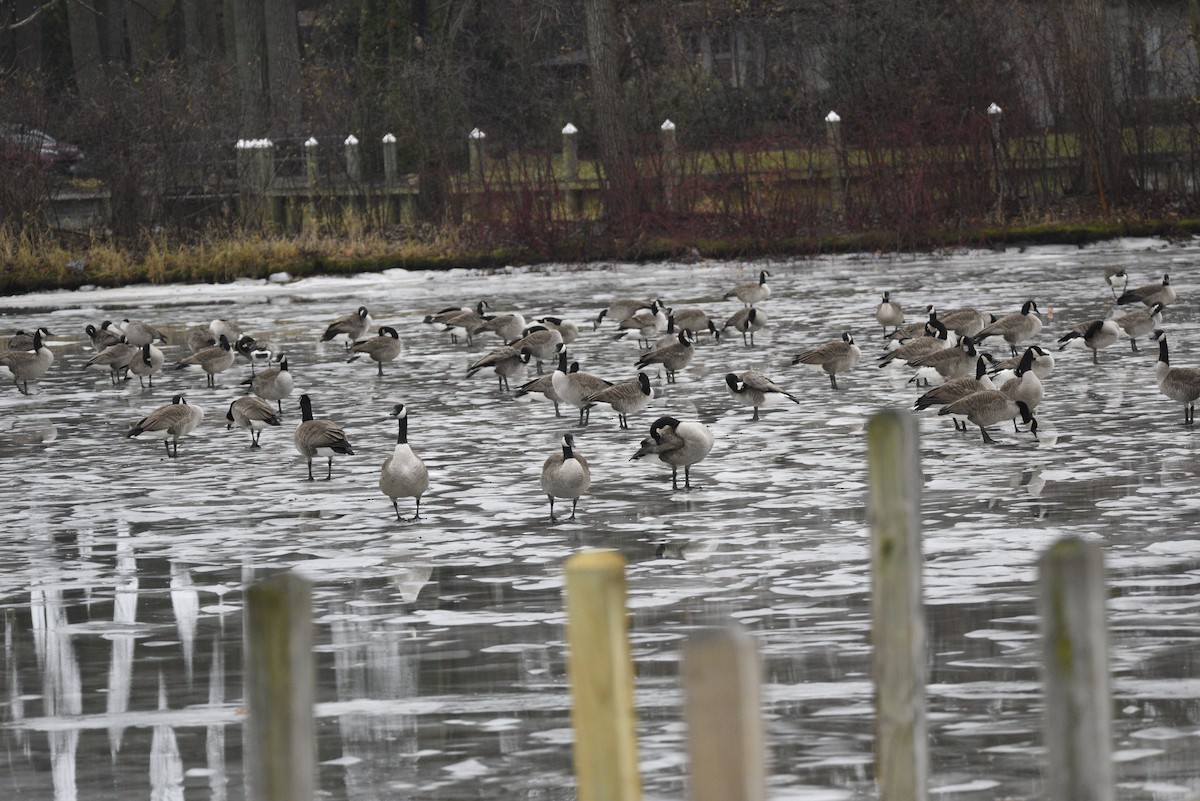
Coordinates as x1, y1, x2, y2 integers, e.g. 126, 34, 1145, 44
0, 240, 1200, 801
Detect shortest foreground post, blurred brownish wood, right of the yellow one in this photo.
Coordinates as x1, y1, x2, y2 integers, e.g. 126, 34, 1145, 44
683, 626, 767, 801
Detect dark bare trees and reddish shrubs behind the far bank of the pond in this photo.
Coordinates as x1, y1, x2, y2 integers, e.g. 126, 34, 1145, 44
0, 0, 1200, 254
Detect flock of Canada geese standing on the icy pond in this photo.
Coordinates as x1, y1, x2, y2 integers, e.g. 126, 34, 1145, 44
0, 267, 1200, 522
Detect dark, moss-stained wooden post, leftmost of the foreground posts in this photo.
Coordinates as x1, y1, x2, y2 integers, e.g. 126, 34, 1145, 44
245, 573, 317, 801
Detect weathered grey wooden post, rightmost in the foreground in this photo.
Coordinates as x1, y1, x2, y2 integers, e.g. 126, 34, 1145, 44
1038, 537, 1116, 801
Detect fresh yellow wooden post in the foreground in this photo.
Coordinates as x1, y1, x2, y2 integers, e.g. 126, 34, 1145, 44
566, 550, 642, 801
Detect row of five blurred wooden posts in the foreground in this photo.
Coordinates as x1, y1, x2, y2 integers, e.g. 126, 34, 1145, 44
246, 410, 1115, 801
